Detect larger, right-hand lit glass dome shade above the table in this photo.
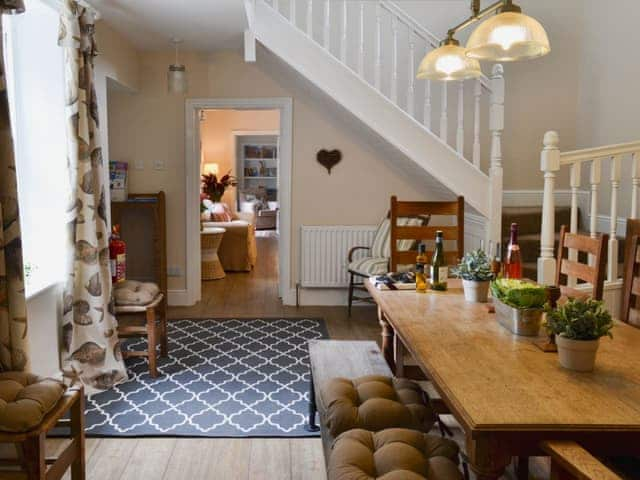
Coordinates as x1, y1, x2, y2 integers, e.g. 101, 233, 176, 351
467, 12, 551, 62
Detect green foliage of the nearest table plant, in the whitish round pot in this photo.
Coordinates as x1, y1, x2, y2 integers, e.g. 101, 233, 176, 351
545, 298, 613, 340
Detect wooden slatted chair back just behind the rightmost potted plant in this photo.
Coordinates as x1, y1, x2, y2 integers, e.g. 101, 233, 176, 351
556, 225, 609, 300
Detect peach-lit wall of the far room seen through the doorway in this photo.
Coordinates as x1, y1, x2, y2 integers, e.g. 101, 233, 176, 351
200, 110, 280, 211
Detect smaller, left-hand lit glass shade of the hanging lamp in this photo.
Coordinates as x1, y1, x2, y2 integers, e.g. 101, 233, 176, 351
416, 44, 482, 82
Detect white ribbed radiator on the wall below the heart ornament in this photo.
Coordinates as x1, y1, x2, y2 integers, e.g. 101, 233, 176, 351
300, 225, 377, 288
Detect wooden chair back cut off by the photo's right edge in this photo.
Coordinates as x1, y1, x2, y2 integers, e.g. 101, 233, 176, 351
620, 219, 640, 327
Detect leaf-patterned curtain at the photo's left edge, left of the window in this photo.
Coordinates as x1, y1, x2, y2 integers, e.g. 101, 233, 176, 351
0, 17, 29, 370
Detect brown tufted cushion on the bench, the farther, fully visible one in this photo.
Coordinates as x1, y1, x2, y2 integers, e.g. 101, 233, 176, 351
320, 375, 435, 437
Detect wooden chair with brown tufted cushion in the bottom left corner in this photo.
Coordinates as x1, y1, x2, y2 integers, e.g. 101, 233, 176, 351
0, 372, 85, 480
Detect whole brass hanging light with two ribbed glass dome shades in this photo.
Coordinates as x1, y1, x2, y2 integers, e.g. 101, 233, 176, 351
417, 0, 551, 81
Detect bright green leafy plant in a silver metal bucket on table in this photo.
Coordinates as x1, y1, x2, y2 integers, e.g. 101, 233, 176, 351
491, 278, 547, 336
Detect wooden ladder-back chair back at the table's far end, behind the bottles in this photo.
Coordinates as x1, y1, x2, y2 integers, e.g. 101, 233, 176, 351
390, 196, 464, 272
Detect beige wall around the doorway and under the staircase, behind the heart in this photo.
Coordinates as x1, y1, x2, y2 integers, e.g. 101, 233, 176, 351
109, 49, 445, 291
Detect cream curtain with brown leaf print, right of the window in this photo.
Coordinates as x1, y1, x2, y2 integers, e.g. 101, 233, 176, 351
59, 0, 127, 394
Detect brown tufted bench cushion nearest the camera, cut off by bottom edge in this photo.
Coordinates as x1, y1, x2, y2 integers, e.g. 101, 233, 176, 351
328, 428, 462, 480
